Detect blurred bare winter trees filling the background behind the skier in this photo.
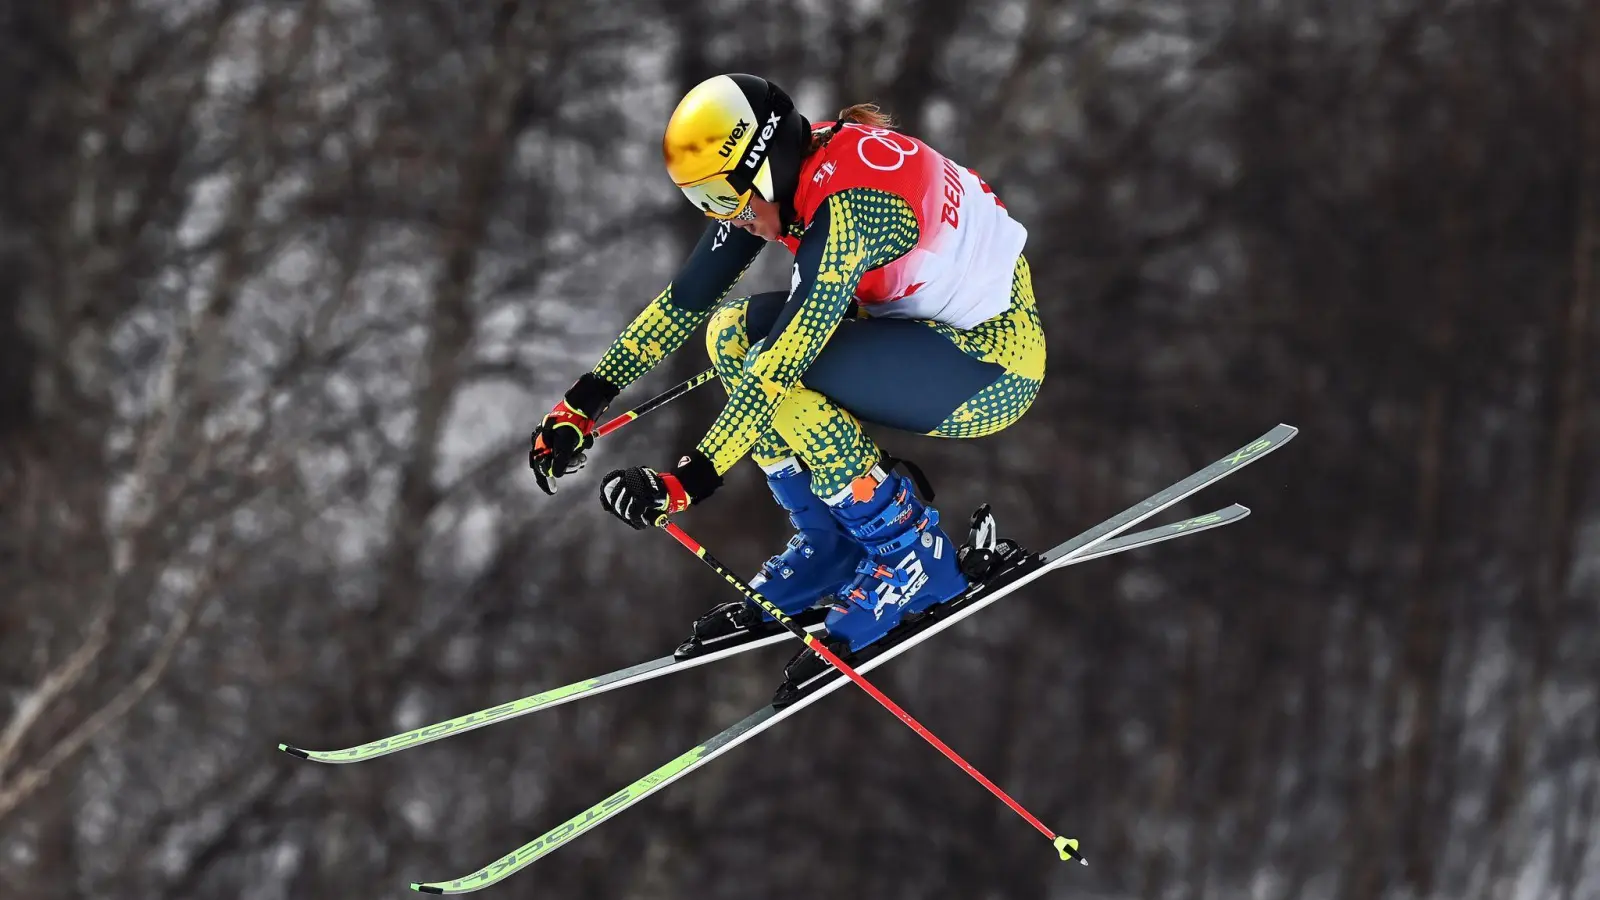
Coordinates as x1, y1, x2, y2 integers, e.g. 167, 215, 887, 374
0, 0, 1600, 900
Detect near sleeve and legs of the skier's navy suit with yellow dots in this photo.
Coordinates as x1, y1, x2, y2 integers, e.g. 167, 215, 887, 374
699, 189, 1045, 498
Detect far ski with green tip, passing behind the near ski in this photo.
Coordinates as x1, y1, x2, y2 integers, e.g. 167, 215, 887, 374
278, 506, 1248, 764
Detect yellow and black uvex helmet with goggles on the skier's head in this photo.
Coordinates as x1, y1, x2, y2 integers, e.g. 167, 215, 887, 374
661, 75, 811, 219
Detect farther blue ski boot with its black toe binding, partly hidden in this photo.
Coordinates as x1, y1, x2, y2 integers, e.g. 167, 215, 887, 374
677, 468, 867, 660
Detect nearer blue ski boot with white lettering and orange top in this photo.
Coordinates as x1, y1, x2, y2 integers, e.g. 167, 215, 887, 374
827, 469, 968, 653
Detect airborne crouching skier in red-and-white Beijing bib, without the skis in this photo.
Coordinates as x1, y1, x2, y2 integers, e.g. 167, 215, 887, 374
530, 74, 1045, 657
